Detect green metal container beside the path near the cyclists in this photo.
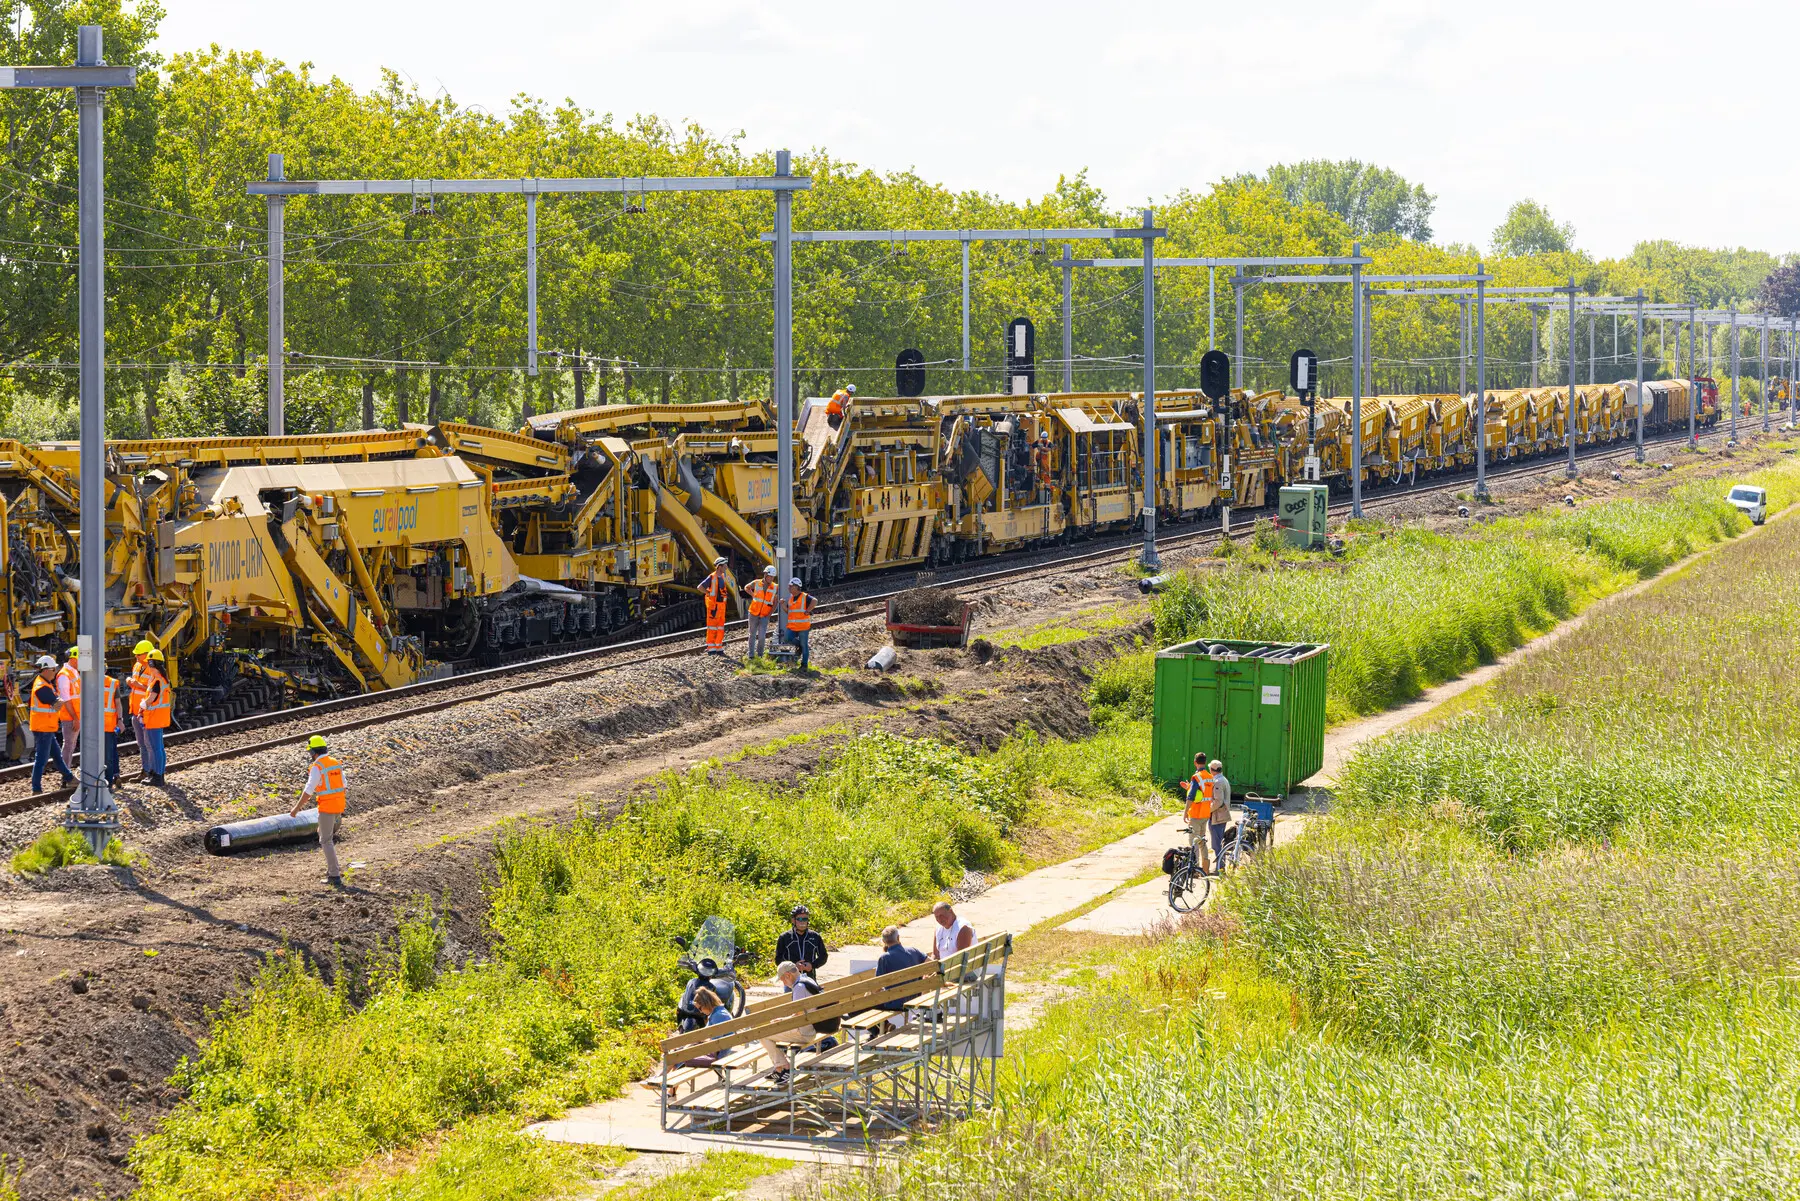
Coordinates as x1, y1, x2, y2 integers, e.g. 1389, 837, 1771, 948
1150, 637, 1330, 798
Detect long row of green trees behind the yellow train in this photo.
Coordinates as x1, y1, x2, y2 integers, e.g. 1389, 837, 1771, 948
0, 0, 1800, 434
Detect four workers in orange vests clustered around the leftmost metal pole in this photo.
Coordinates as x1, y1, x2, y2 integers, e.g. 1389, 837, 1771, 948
14, 639, 175, 794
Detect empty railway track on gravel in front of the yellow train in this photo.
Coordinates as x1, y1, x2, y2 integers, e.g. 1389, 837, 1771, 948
0, 417, 1724, 816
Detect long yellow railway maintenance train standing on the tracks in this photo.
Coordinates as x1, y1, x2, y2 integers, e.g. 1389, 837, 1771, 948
0, 380, 1717, 754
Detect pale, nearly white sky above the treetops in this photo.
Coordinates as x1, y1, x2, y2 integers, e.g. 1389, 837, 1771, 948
160, 0, 1800, 256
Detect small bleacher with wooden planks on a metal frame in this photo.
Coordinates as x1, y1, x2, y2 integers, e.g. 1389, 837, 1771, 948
653, 935, 1012, 1143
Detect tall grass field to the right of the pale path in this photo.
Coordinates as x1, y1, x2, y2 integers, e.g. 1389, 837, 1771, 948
841, 455, 1800, 1201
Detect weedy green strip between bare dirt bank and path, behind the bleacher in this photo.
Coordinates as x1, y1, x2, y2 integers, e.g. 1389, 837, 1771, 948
131, 724, 1166, 1201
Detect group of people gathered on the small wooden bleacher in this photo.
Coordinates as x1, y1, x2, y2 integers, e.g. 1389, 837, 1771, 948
680, 900, 976, 1086
